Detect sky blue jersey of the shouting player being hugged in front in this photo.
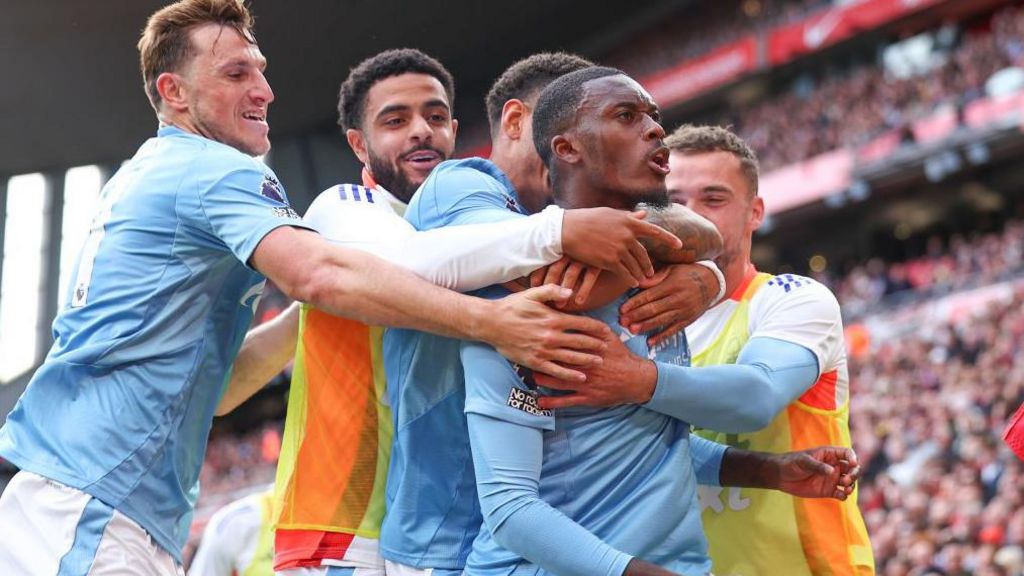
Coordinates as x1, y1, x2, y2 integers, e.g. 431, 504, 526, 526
462, 287, 712, 576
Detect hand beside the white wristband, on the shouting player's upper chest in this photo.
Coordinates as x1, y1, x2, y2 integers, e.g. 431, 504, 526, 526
618, 264, 719, 346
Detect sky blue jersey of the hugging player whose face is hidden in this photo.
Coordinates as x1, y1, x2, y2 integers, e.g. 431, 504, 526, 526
381, 158, 525, 569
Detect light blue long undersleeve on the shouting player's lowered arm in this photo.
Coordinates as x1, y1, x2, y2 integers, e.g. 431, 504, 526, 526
467, 414, 632, 576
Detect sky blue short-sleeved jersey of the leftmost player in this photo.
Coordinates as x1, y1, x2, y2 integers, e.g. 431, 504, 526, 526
0, 127, 304, 562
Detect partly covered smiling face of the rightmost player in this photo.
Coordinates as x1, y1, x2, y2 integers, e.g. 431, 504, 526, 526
666, 152, 764, 269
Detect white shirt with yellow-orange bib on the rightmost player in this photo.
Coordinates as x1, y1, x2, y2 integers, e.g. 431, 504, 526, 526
686, 266, 874, 576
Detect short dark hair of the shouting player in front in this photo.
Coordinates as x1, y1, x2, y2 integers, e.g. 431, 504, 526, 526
534, 66, 626, 169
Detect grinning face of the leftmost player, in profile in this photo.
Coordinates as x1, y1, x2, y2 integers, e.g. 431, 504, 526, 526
182, 24, 273, 156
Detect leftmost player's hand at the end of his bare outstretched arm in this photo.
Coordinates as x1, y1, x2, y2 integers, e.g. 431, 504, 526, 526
475, 284, 611, 383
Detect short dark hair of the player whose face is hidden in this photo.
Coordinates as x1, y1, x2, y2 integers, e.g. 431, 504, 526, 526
484, 52, 594, 136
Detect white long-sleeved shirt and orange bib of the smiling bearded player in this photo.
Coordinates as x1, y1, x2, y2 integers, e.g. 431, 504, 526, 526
274, 171, 561, 570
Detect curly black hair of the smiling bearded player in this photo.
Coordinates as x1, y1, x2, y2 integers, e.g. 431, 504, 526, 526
338, 48, 455, 130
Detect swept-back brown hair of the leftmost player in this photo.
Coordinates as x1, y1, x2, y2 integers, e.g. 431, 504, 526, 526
138, 0, 256, 112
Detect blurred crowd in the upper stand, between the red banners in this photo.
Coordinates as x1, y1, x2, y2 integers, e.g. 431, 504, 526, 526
729, 6, 1024, 170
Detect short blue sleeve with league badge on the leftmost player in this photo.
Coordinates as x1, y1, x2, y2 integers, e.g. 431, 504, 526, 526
199, 168, 312, 264
